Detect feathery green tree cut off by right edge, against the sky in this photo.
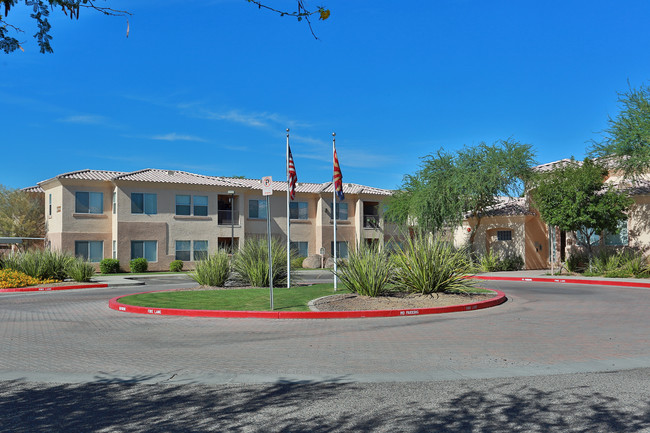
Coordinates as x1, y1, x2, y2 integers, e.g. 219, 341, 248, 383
591, 82, 650, 178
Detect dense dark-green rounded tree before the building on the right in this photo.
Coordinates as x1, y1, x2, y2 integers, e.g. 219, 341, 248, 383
530, 158, 634, 254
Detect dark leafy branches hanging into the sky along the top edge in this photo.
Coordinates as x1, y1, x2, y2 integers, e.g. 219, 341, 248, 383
0, 0, 330, 53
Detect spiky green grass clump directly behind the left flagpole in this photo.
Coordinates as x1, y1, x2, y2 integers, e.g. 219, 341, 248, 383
233, 237, 294, 287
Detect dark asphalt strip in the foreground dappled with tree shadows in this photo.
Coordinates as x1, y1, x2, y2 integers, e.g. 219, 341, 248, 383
0, 378, 650, 432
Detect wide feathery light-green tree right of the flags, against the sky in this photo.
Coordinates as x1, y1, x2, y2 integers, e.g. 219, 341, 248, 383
387, 139, 535, 243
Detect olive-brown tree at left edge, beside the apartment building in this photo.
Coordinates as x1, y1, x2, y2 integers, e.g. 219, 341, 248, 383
0, 185, 45, 238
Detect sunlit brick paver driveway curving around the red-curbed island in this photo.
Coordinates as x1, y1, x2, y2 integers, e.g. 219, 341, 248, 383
0, 280, 650, 383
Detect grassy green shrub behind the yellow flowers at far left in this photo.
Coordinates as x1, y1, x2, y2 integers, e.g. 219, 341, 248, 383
4, 250, 74, 281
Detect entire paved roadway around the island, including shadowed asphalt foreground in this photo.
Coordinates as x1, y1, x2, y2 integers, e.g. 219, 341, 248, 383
0, 278, 650, 432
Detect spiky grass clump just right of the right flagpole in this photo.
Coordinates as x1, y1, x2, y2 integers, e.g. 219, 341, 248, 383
336, 244, 393, 296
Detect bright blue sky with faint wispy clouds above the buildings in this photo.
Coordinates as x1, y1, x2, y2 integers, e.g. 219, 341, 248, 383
0, 0, 650, 188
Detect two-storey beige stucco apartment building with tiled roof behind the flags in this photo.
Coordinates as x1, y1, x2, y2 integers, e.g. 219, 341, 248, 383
38, 169, 395, 270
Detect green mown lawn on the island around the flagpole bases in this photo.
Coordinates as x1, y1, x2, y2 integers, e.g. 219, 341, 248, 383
120, 283, 348, 311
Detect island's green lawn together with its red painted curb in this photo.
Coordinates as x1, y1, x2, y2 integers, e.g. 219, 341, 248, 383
109, 284, 506, 319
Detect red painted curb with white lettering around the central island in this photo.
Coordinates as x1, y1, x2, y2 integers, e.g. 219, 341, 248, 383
108, 290, 506, 319
